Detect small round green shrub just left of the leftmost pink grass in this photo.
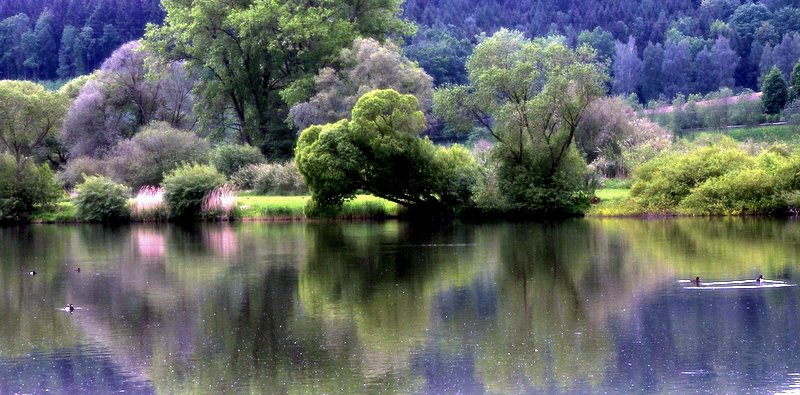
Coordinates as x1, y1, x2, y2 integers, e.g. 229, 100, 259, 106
74, 176, 130, 222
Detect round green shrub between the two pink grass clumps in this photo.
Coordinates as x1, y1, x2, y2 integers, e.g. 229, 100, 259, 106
163, 164, 225, 220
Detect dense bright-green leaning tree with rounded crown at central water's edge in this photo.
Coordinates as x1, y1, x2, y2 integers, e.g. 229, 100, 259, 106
295, 89, 478, 215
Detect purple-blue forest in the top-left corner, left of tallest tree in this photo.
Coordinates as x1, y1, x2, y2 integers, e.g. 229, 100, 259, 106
0, 0, 164, 80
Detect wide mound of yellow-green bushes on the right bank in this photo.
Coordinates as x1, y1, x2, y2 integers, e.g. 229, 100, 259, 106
631, 139, 800, 215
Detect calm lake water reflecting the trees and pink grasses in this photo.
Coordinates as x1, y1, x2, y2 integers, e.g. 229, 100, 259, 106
0, 219, 800, 394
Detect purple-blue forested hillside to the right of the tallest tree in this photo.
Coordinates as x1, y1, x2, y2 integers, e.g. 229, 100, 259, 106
404, 0, 800, 103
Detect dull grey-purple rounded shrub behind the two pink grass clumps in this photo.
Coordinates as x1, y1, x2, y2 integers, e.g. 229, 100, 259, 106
106, 123, 210, 192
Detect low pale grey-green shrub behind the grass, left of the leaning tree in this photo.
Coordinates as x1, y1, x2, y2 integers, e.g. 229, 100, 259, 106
232, 161, 308, 195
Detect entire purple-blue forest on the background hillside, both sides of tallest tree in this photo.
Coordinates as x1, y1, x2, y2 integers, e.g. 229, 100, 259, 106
0, 0, 800, 103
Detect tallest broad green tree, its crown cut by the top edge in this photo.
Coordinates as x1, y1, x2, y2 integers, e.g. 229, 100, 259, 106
146, 0, 411, 161
